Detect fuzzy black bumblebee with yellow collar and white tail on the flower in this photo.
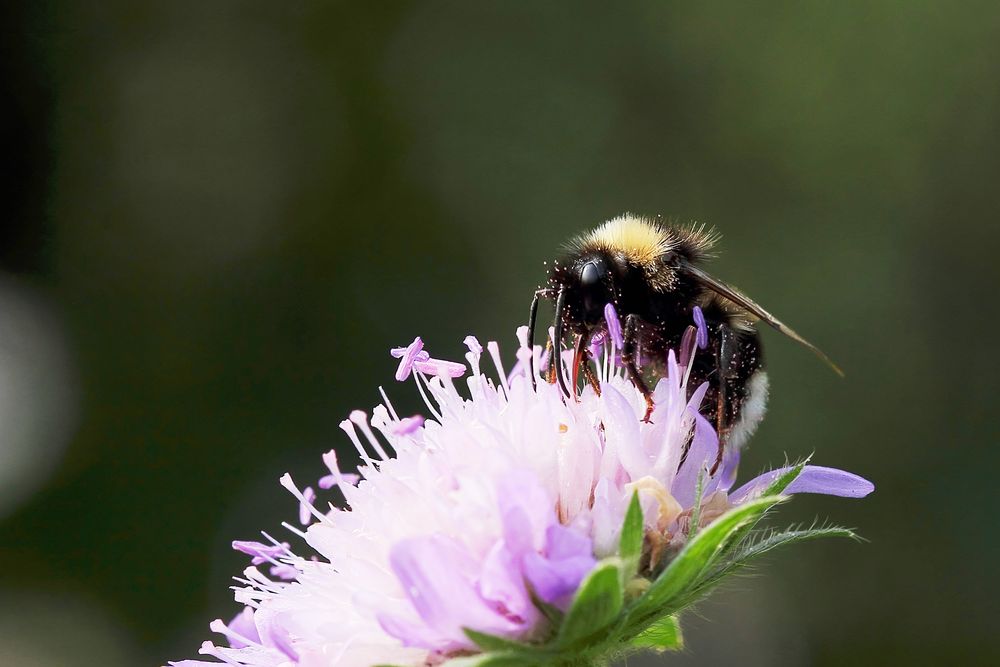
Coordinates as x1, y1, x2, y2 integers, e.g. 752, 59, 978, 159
528, 214, 842, 472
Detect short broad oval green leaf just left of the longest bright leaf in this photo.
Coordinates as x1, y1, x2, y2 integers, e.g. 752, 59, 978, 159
557, 558, 624, 646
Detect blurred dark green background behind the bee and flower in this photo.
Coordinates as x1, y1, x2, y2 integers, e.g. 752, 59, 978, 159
0, 0, 1000, 667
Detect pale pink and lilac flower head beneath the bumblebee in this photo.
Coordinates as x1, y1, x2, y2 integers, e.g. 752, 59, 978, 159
171, 304, 873, 667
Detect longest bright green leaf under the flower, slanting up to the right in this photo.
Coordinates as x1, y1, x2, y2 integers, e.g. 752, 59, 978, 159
629, 496, 785, 620
